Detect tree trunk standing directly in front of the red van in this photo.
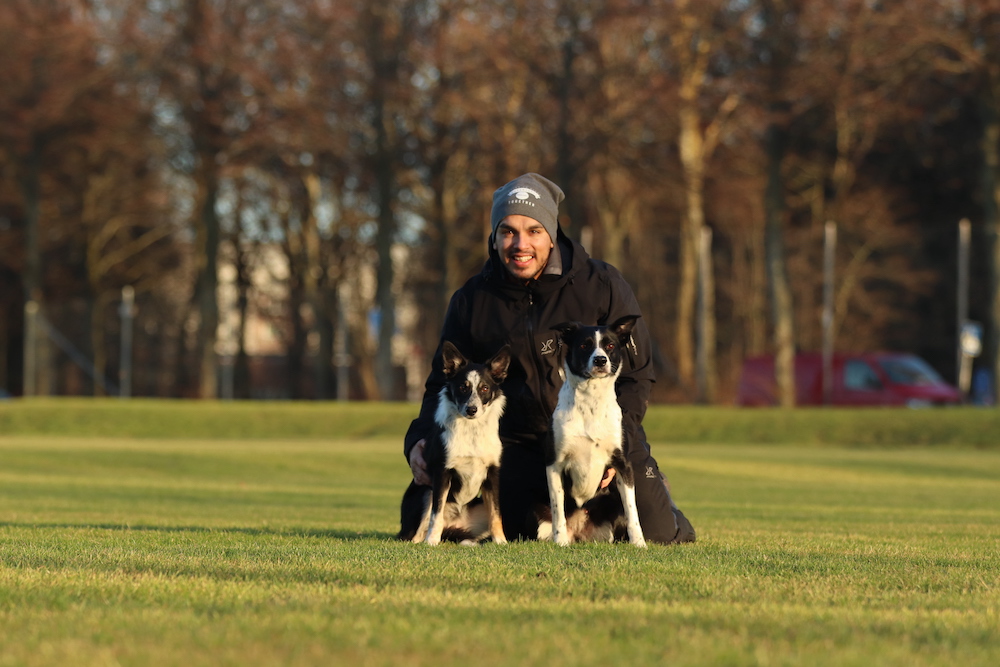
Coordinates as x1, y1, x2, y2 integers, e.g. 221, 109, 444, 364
764, 124, 795, 408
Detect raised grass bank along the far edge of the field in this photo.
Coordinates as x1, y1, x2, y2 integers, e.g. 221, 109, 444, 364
0, 398, 1000, 450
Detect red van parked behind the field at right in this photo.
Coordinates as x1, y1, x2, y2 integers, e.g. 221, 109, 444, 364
736, 352, 962, 407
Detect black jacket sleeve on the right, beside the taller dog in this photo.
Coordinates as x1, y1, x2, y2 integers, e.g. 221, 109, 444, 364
607, 267, 655, 458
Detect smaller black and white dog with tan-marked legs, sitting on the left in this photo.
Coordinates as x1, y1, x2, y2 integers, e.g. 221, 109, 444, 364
397, 341, 510, 544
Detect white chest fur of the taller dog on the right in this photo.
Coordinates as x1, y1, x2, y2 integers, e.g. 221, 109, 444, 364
552, 373, 622, 505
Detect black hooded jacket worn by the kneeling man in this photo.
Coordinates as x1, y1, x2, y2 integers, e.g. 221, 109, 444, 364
403, 230, 653, 459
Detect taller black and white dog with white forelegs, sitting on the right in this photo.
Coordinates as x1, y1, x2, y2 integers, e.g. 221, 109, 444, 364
539, 315, 646, 547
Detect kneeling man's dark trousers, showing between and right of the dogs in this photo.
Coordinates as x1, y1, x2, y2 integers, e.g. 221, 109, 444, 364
500, 430, 694, 544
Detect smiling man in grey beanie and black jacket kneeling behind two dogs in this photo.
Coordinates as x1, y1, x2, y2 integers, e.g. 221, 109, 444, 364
403, 173, 695, 543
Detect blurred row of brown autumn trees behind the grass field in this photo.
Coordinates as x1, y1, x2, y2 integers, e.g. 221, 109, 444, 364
0, 0, 1000, 402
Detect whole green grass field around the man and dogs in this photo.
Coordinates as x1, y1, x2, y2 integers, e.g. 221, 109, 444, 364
0, 401, 1000, 667
